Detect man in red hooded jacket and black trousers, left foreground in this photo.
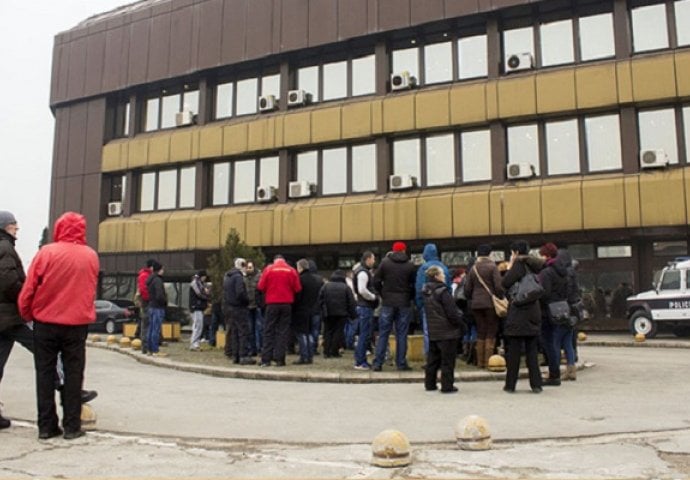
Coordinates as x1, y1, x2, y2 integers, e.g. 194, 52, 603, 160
18, 212, 99, 440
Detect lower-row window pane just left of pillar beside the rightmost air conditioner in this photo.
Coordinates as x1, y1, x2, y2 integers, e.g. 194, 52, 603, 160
585, 114, 622, 172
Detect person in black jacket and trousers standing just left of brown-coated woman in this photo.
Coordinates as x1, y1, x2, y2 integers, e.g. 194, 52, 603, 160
422, 266, 467, 393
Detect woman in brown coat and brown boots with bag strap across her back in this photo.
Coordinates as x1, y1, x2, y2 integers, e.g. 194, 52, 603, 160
464, 244, 503, 368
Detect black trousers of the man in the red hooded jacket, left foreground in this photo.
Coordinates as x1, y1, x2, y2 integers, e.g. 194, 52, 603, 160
34, 321, 88, 433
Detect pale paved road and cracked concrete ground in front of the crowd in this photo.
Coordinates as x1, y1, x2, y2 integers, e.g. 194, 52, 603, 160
0, 336, 690, 479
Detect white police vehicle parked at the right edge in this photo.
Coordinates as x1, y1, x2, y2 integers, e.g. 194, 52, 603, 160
626, 257, 690, 338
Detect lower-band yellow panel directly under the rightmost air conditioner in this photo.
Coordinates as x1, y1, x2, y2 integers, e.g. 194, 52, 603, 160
640, 169, 687, 227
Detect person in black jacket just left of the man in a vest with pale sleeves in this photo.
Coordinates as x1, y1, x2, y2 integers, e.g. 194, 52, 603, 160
319, 270, 357, 358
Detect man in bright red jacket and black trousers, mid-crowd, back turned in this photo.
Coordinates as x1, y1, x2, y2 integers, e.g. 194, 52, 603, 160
256, 255, 302, 367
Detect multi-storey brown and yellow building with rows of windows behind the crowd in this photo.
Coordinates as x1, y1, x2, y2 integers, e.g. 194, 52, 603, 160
51, 0, 690, 316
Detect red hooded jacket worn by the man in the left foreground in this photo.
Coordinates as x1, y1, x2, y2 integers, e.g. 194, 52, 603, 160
18, 212, 99, 325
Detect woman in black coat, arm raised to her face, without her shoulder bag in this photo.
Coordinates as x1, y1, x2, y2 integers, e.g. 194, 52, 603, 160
501, 240, 543, 393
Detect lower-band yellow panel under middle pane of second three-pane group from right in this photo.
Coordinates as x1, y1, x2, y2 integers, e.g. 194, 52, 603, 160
541, 181, 582, 233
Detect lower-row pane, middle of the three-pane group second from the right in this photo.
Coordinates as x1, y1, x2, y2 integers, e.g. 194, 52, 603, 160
546, 119, 580, 175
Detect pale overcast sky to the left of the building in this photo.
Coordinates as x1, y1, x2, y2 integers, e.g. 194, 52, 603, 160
0, 0, 134, 268
